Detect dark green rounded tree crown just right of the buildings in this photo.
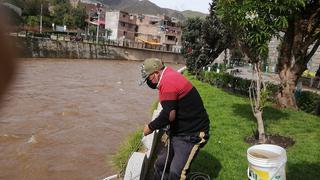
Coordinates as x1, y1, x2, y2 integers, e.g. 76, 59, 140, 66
182, 2, 231, 74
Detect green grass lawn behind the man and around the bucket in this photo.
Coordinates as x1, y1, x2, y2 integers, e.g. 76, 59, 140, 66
188, 76, 320, 180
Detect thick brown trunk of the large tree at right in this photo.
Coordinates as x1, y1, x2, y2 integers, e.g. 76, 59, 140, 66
277, 0, 320, 108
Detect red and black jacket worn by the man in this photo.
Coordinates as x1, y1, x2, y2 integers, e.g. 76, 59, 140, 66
149, 67, 209, 135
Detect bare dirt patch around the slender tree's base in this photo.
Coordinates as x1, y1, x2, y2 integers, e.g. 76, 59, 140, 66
244, 134, 295, 148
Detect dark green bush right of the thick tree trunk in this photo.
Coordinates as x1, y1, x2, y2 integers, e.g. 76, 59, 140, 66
297, 91, 320, 115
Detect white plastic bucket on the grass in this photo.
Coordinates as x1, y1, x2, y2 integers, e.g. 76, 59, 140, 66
247, 144, 287, 180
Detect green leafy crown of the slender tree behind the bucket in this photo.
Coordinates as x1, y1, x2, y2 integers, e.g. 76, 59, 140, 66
218, 0, 291, 63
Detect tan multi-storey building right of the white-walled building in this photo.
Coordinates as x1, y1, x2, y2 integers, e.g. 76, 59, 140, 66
136, 14, 182, 51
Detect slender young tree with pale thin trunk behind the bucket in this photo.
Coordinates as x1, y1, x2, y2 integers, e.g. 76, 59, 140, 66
218, 0, 287, 143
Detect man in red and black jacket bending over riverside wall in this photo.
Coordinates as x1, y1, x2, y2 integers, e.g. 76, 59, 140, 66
141, 58, 209, 180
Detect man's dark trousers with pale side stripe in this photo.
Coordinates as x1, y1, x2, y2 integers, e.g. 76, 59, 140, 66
154, 133, 208, 180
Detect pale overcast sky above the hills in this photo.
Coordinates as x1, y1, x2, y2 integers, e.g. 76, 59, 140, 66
149, 0, 212, 14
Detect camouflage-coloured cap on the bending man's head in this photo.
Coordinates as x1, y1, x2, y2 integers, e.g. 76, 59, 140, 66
140, 58, 164, 85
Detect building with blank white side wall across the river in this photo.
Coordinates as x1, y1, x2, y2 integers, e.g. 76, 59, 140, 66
105, 11, 137, 41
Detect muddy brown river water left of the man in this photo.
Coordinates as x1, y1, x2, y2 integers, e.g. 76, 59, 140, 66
0, 59, 182, 180
